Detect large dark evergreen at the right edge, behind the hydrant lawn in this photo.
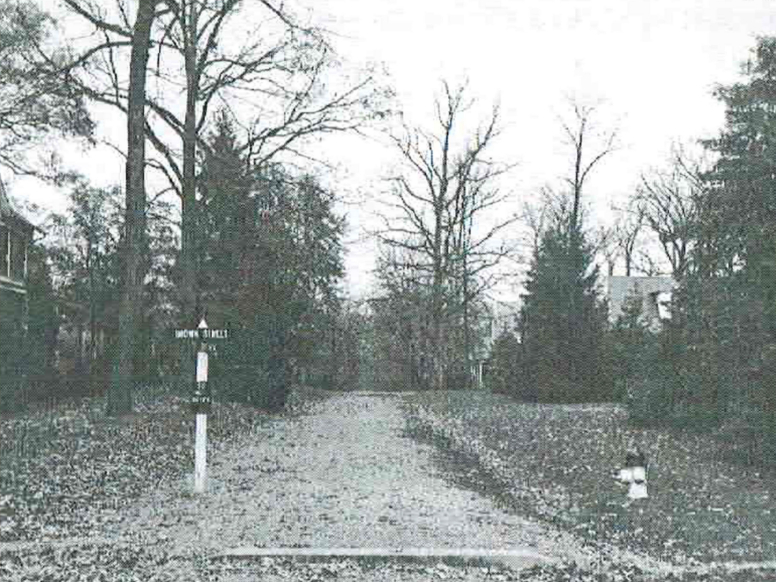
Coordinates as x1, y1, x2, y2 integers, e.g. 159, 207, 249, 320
632, 37, 776, 438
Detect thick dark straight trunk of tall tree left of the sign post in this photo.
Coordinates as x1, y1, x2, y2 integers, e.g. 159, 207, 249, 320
106, 0, 158, 416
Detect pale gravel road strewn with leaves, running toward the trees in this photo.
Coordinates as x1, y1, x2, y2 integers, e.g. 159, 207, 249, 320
111, 393, 589, 576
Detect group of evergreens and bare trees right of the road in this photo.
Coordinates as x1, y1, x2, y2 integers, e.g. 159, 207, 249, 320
484, 37, 776, 462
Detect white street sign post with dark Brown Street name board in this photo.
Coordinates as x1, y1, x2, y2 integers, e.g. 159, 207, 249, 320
175, 319, 229, 493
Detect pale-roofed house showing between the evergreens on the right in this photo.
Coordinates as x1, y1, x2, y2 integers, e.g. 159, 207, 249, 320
606, 276, 676, 331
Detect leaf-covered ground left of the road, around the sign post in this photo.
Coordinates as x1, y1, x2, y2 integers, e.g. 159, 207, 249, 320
0, 389, 328, 581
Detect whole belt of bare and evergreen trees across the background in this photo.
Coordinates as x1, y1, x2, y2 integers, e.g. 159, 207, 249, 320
0, 0, 776, 466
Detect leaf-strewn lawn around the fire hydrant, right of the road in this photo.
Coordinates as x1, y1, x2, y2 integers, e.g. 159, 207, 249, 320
404, 392, 776, 579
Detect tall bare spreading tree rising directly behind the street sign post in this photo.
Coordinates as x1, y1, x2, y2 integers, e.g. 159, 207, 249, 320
59, 0, 383, 410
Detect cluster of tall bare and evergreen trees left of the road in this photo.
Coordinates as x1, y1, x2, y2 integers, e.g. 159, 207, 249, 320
0, 0, 390, 414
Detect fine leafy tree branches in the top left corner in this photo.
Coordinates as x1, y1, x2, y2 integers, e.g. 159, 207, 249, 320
0, 0, 94, 175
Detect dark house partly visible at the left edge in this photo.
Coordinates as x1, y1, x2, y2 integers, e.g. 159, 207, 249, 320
0, 179, 35, 375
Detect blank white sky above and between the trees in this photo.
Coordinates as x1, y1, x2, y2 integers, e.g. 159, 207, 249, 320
12, 0, 776, 302
